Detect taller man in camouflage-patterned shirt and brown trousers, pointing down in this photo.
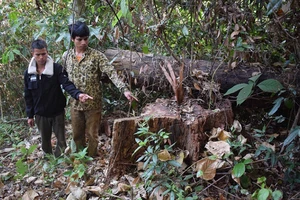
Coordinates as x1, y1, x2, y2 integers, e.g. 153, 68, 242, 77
63, 21, 134, 156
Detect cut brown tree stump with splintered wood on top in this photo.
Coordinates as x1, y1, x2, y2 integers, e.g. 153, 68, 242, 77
107, 99, 233, 178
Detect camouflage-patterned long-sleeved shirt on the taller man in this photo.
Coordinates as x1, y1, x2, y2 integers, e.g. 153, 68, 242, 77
62, 47, 127, 111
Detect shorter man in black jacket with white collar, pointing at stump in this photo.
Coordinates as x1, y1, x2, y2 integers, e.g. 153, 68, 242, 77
24, 39, 93, 157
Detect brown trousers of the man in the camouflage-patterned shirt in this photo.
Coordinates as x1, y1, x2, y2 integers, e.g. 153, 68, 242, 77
71, 109, 101, 156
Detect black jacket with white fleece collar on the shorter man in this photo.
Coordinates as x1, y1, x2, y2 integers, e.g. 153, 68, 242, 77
24, 60, 82, 118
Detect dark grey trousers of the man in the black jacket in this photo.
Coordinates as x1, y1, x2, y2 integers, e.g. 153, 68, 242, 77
35, 112, 67, 157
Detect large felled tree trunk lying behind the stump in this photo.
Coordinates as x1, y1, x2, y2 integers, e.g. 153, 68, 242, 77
105, 49, 300, 93
